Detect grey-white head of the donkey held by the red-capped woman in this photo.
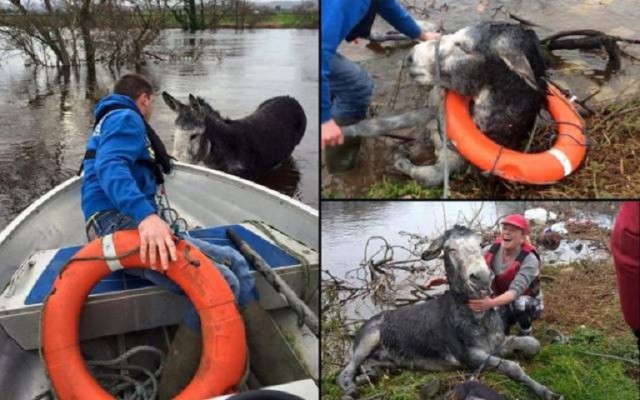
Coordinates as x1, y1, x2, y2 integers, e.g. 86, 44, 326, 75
422, 225, 491, 298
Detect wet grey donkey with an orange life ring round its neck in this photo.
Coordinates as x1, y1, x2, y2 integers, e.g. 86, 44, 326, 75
394, 22, 547, 186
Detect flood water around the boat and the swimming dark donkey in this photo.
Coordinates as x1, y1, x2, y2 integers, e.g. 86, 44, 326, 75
0, 29, 319, 229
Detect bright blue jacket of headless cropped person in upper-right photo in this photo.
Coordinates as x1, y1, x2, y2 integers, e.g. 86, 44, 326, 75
320, 0, 421, 123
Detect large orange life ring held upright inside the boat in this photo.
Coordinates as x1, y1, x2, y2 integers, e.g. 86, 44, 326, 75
41, 230, 247, 400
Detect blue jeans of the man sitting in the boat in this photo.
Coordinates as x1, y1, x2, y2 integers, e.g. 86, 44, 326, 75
87, 210, 258, 332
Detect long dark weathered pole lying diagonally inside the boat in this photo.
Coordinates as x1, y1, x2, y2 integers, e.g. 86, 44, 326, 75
226, 229, 320, 337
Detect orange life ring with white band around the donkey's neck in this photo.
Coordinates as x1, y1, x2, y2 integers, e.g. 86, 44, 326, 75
445, 85, 587, 185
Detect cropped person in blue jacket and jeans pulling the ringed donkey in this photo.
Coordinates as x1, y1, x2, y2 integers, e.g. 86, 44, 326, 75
320, 0, 440, 153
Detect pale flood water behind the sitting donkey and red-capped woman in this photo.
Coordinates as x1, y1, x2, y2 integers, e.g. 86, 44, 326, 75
322, 201, 618, 278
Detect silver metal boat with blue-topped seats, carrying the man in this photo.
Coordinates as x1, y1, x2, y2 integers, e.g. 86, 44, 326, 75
0, 163, 320, 400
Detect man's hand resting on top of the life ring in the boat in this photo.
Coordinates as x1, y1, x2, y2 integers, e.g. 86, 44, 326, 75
138, 214, 178, 271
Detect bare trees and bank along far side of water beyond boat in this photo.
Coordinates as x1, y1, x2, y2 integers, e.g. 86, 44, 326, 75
0, 0, 319, 69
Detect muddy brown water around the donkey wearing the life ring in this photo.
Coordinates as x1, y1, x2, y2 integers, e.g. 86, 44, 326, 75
322, 0, 640, 198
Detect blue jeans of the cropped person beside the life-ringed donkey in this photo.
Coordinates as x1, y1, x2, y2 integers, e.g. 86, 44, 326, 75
329, 53, 373, 122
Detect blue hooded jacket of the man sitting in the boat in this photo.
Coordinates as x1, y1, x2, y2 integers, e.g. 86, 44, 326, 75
82, 94, 157, 224
